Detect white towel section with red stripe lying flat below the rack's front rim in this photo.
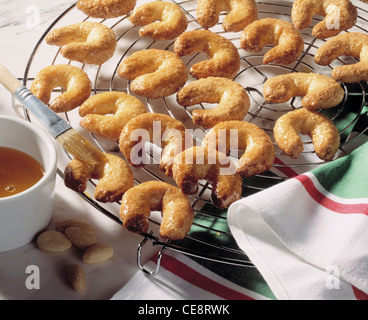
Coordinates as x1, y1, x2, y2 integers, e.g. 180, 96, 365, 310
111, 250, 274, 301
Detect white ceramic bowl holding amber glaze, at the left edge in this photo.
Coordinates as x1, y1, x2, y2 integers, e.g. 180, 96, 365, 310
0, 116, 57, 252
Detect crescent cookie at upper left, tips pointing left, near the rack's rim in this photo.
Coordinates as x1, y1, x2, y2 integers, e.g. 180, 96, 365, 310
46, 21, 117, 65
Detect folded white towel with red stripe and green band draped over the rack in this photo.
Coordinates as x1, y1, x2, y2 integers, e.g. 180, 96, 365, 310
228, 142, 368, 300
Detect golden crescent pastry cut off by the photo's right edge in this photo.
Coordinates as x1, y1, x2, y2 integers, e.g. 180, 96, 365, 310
314, 32, 368, 83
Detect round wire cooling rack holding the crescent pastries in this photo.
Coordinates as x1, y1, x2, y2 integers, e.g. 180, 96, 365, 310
19, 0, 368, 275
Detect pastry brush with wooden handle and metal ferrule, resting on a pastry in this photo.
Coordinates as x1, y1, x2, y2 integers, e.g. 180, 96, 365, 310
0, 63, 105, 164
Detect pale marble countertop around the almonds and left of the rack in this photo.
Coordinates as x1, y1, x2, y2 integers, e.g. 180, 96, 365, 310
0, 0, 156, 300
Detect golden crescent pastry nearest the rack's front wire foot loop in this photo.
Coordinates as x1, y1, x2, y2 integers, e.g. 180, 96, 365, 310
120, 181, 194, 240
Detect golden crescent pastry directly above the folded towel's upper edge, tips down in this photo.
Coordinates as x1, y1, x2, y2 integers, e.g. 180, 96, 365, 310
274, 108, 340, 161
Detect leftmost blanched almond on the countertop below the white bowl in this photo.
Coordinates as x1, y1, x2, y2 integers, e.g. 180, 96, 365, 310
37, 230, 72, 252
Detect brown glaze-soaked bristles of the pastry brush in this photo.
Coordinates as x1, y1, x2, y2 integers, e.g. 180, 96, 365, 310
56, 129, 105, 164
